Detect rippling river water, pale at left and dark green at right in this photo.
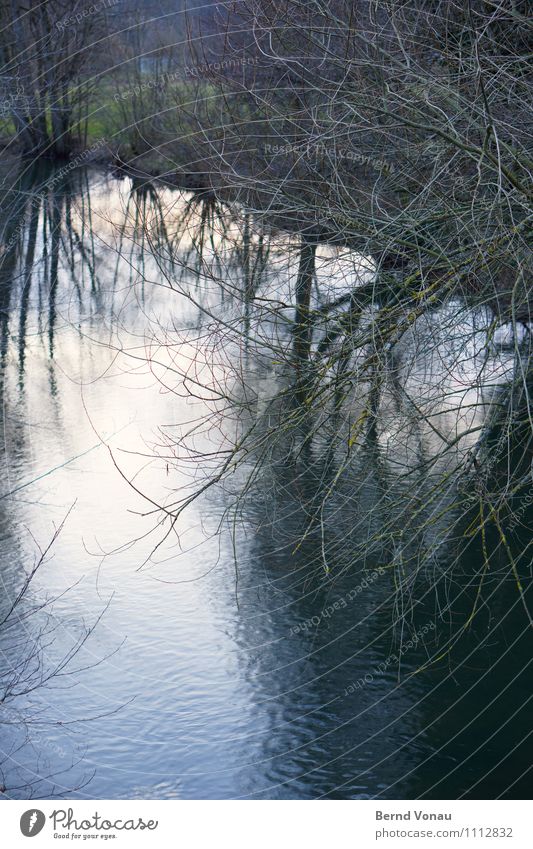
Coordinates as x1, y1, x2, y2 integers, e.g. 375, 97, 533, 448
0, 161, 532, 799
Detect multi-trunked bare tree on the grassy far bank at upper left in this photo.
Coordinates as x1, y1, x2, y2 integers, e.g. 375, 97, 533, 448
0, 0, 117, 157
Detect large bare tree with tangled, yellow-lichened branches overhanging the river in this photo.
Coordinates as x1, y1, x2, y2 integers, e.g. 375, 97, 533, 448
111, 0, 533, 644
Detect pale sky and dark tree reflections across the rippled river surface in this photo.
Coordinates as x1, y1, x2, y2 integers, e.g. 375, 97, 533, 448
0, 164, 531, 798
